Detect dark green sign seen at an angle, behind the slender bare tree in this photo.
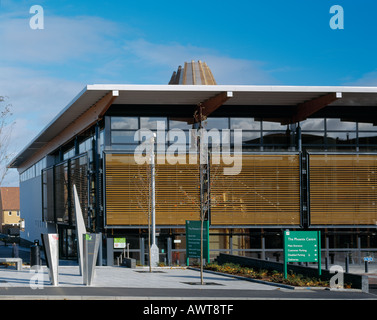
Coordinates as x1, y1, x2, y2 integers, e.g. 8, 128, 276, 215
186, 220, 209, 265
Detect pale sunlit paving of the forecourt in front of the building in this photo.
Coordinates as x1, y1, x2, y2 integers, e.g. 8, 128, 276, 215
0, 266, 276, 290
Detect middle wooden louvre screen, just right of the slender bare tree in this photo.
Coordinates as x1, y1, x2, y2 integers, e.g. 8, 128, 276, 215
211, 154, 300, 225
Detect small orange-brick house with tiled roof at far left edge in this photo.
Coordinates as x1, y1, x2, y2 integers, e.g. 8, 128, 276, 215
0, 187, 21, 234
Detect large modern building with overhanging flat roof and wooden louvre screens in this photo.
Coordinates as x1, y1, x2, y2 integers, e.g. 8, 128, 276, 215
9, 62, 377, 265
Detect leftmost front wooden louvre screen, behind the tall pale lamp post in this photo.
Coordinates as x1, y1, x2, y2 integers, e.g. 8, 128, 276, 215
105, 154, 200, 226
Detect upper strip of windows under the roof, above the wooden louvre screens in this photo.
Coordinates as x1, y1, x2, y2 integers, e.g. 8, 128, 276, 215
109, 117, 377, 151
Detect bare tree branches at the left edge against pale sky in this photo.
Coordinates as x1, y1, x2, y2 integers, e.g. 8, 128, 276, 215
0, 96, 14, 186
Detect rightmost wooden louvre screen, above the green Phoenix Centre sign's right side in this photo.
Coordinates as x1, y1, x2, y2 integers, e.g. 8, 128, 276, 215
309, 154, 377, 225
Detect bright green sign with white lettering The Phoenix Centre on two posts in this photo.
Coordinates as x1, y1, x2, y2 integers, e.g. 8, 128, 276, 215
284, 230, 321, 278
